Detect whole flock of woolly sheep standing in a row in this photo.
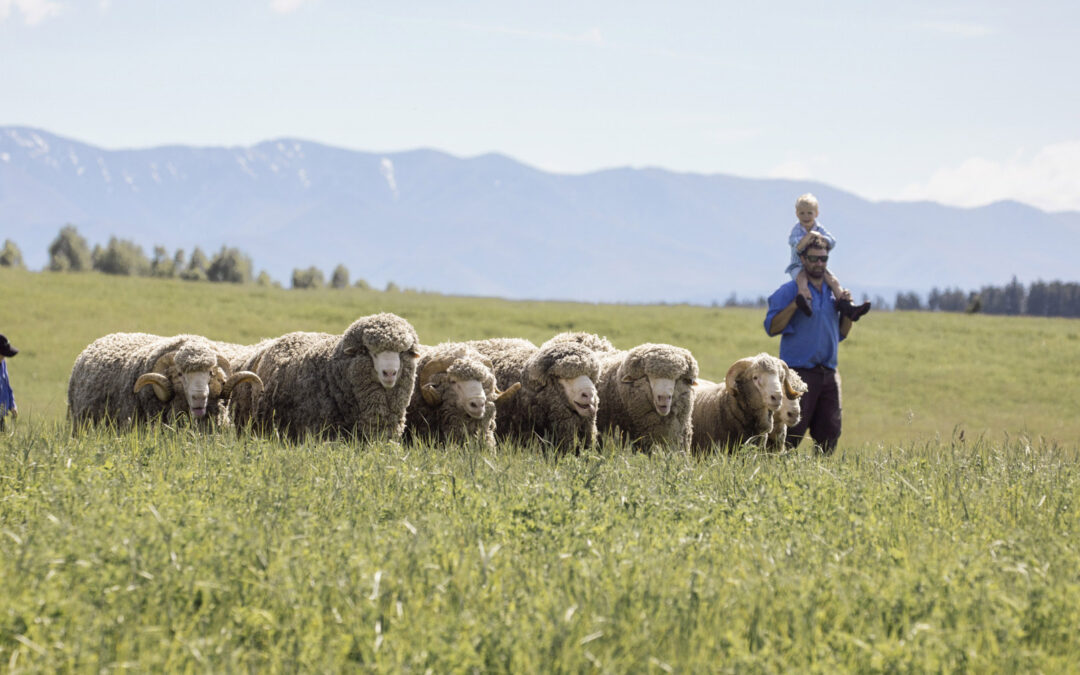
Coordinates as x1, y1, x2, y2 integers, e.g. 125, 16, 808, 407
68, 313, 807, 454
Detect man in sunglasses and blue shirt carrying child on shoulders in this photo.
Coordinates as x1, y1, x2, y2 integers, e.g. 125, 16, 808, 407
765, 234, 851, 455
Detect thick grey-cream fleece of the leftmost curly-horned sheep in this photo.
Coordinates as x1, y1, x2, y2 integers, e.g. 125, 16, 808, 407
68, 333, 228, 427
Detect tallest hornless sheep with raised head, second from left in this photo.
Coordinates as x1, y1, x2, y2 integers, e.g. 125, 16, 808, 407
234, 313, 419, 442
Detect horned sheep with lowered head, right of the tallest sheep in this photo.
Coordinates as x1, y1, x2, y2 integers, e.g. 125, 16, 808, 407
405, 342, 521, 448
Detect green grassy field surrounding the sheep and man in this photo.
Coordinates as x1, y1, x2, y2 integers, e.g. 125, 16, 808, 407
0, 269, 1080, 673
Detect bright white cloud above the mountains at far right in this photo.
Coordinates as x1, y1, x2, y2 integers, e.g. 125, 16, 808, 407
901, 140, 1080, 211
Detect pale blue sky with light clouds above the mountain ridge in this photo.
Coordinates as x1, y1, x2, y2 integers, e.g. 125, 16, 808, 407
0, 0, 1080, 211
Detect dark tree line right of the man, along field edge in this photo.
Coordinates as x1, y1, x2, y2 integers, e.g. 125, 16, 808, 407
896, 276, 1080, 318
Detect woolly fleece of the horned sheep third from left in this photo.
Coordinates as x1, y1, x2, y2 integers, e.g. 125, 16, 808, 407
405, 342, 496, 448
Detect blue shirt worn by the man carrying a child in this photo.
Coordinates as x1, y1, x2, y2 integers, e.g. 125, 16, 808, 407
765, 281, 843, 370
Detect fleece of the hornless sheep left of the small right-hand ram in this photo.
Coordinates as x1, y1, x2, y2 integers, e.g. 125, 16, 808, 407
596, 343, 698, 450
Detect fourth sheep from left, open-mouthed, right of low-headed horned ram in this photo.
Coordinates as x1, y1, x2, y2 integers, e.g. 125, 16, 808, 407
469, 338, 599, 453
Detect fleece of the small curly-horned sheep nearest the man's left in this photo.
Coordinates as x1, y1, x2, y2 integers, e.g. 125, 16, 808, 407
693, 354, 783, 454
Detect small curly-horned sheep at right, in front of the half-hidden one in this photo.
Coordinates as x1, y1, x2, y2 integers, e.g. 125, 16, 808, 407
692, 352, 784, 454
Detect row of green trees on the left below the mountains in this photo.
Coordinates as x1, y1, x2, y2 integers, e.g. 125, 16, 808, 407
0, 225, 399, 292
